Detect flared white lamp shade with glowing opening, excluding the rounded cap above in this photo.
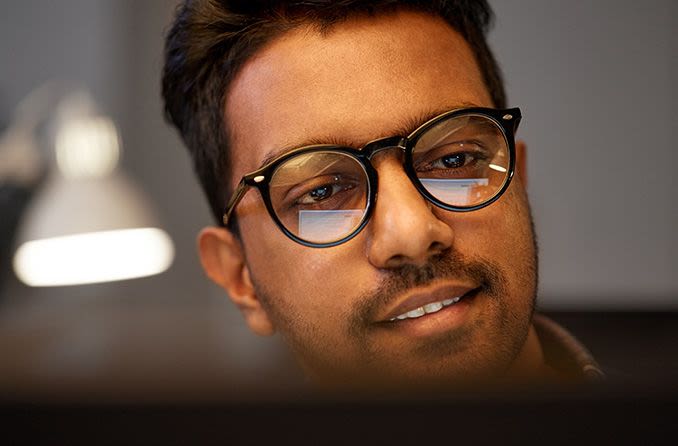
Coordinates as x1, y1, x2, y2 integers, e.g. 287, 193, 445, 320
14, 172, 174, 286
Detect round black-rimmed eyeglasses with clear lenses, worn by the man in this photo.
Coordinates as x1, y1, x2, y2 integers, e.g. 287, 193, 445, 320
223, 108, 521, 248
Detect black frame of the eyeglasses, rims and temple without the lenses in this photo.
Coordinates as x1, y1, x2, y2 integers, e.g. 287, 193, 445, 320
223, 107, 522, 248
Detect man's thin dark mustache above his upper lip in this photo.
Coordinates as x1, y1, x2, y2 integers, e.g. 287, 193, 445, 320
351, 248, 506, 328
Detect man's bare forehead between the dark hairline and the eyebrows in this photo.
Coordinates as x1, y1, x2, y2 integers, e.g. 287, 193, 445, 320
225, 12, 492, 184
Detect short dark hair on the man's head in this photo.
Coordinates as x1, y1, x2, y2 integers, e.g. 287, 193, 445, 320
162, 0, 506, 222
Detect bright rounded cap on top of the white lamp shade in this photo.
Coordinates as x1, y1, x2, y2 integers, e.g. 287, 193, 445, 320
55, 116, 120, 178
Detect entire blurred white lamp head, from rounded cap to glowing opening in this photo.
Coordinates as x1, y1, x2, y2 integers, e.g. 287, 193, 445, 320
13, 87, 174, 286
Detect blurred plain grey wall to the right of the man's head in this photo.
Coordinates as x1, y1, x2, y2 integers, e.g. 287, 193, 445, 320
491, 0, 678, 308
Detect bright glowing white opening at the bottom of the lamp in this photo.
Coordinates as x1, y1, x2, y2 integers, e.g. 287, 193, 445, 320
14, 228, 174, 287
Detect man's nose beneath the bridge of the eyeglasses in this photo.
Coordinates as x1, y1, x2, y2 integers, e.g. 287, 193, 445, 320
366, 153, 454, 268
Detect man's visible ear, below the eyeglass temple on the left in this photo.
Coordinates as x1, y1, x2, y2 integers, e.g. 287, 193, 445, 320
198, 227, 275, 336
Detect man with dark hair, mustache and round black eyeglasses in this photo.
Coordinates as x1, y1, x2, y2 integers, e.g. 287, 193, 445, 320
163, 0, 602, 389
